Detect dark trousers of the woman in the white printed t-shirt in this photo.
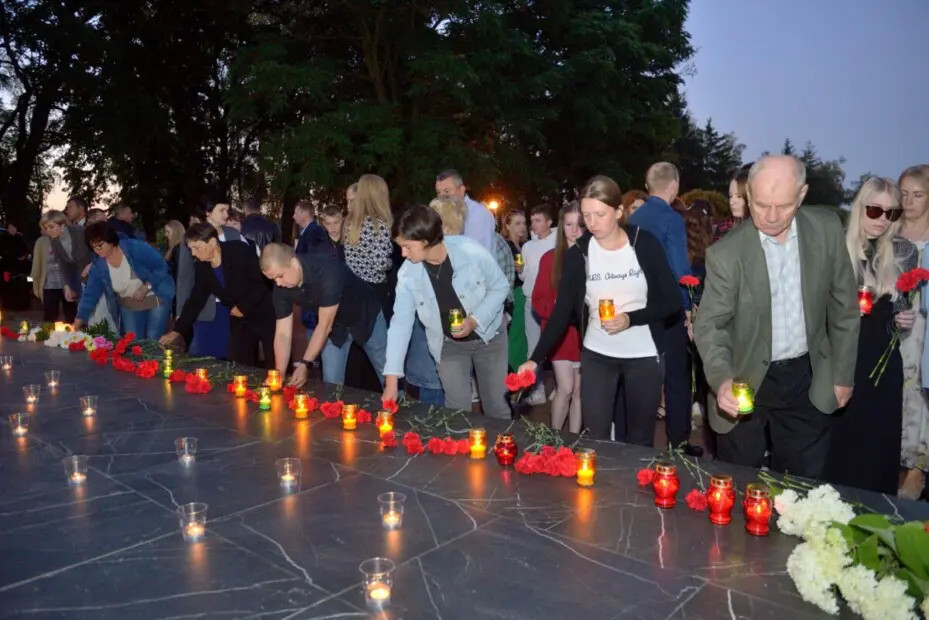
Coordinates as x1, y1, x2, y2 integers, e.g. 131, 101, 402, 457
581, 349, 662, 447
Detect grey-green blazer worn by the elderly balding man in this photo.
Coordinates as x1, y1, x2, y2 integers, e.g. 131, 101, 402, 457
694, 207, 860, 433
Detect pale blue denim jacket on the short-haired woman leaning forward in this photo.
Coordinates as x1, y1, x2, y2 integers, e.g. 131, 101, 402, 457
384, 235, 510, 377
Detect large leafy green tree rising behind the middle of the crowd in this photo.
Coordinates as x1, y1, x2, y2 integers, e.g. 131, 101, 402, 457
230, 0, 692, 209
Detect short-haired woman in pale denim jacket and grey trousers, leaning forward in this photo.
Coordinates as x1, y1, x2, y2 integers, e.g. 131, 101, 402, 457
382, 206, 510, 418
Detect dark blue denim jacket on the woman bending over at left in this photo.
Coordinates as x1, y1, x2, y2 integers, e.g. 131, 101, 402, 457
77, 235, 174, 330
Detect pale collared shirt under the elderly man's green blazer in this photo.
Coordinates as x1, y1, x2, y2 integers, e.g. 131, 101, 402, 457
758, 218, 809, 362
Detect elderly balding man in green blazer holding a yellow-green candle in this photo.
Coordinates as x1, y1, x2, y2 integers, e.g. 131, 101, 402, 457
694, 156, 859, 478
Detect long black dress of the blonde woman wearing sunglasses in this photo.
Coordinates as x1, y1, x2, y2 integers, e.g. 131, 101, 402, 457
826, 295, 903, 495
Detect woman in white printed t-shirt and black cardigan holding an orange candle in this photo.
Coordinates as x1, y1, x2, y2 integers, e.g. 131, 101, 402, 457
520, 176, 681, 446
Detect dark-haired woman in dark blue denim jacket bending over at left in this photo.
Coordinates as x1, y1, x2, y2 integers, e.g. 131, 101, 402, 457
74, 222, 174, 339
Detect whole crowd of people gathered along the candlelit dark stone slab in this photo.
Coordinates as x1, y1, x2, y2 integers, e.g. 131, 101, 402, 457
12, 156, 929, 498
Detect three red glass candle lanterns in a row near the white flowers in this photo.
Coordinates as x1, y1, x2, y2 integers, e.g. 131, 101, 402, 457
652, 462, 774, 536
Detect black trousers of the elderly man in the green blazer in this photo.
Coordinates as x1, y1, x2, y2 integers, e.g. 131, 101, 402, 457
717, 355, 833, 479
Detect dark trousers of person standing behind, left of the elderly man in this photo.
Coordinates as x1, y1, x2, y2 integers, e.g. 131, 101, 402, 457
664, 310, 692, 447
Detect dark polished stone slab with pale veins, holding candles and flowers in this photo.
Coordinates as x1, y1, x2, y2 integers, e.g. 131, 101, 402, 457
0, 342, 929, 620
